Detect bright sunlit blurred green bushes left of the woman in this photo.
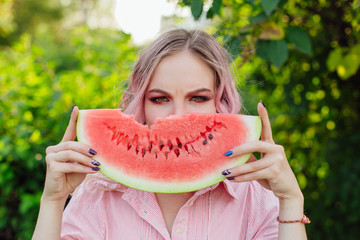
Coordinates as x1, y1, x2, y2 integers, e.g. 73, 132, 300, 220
0, 27, 136, 239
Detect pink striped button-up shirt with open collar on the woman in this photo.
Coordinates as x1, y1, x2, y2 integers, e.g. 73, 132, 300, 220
61, 174, 279, 240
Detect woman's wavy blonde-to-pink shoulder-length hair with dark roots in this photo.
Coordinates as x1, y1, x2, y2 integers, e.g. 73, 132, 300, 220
120, 29, 241, 124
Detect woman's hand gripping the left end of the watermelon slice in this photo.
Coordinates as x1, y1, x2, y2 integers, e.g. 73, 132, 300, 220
42, 106, 100, 202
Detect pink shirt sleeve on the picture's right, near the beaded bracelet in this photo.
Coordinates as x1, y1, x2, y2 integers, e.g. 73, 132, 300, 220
248, 181, 279, 240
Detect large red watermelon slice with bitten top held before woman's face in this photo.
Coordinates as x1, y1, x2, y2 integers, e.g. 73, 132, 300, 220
77, 109, 261, 193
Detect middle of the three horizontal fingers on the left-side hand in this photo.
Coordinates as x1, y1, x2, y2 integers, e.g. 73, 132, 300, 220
46, 150, 100, 167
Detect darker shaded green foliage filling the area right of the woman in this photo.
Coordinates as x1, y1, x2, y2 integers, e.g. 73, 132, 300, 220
179, 0, 360, 239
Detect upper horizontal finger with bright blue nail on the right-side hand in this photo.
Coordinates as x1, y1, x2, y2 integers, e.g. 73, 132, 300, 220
225, 141, 279, 157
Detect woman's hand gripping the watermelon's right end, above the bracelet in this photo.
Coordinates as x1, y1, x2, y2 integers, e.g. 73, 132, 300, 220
223, 102, 303, 200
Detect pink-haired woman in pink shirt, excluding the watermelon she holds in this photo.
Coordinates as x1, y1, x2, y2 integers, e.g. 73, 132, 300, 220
33, 30, 306, 239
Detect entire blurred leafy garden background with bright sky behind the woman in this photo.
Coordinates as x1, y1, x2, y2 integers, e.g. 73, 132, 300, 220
0, 0, 360, 240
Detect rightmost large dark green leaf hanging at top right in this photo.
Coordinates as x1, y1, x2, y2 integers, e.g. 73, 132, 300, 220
286, 27, 311, 55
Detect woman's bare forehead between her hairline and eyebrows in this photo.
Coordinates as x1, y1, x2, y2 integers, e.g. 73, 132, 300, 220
148, 51, 215, 90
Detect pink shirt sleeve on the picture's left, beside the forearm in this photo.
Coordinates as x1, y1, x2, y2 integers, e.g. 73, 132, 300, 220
61, 180, 106, 240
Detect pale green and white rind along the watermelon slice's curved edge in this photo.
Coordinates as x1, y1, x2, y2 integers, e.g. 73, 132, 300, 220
77, 110, 262, 193
